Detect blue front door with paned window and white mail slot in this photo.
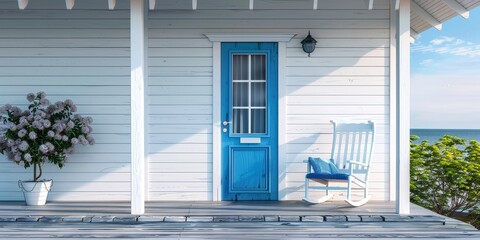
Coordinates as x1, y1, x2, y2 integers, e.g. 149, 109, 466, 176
221, 43, 278, 200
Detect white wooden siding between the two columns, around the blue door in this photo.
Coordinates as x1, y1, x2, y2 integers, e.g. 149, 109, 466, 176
148, 0, 390, 200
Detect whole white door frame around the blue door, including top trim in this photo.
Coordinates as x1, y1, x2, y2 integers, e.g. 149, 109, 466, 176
204, 33, 296, 201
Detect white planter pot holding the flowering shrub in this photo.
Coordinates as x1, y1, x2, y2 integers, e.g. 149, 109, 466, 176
18, 179, 53, 206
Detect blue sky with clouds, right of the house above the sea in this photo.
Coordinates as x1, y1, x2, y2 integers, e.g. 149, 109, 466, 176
411, 7, 480, 129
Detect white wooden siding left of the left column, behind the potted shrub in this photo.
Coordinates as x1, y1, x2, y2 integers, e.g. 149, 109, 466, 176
0, 0, 130, 201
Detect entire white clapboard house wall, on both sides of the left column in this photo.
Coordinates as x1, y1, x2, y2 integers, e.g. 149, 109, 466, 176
0, 0, 391, 201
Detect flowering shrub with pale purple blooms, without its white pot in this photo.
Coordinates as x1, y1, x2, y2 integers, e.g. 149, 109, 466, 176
0, 92, 95, 181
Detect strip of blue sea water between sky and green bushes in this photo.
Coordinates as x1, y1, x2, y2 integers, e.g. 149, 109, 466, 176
410, 129, 480, 143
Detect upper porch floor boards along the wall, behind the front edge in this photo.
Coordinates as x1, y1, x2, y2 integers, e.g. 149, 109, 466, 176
0, 201, 402, 216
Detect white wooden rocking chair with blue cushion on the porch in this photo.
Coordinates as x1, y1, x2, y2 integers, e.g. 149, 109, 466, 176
303, 121, 375, 207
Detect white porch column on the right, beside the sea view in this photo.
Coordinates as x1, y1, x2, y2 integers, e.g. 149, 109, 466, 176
396, 0, 410, 214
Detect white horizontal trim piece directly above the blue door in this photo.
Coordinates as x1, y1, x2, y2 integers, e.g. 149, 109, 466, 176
203, 33, 297, 42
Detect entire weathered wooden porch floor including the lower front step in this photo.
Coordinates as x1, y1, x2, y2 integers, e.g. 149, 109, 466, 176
0, 201, 480, 239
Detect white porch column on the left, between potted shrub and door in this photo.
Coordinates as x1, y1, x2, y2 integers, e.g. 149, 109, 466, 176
130, 0, 146, 214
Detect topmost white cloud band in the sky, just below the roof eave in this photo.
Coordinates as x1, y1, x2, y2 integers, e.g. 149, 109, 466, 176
411, 36, 480, 58
